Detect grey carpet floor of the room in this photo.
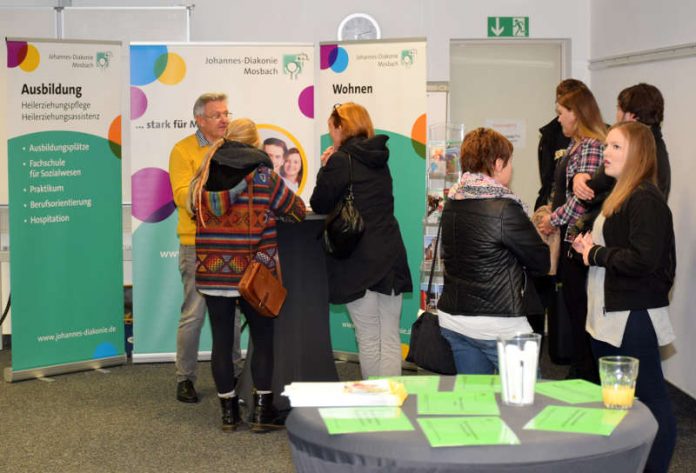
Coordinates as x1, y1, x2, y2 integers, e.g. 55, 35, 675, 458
0, 344, 696, 473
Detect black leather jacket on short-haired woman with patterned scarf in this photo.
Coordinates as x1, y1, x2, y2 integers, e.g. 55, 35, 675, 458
438, 198, 549, 317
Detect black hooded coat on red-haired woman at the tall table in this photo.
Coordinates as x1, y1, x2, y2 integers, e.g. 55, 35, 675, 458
309, 135, 413, 304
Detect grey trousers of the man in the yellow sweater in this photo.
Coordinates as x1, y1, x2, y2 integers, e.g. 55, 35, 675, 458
176, 245, 242, 383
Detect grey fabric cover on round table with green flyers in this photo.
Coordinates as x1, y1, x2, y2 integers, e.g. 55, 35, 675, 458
286, 376, 657, 473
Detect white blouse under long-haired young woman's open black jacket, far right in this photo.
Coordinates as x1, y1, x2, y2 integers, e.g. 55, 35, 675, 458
585, 213, 676, 348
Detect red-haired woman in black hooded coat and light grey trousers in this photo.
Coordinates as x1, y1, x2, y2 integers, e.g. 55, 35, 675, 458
310, 102, 413, 378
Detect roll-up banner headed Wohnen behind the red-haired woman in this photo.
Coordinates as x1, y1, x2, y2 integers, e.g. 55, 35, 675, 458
315, 39, 427, 353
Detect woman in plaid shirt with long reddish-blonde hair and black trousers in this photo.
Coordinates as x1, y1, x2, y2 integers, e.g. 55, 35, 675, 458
538, 88, 606, 382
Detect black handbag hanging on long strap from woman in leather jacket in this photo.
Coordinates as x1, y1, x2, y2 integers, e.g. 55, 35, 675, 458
406, 220, 457, 375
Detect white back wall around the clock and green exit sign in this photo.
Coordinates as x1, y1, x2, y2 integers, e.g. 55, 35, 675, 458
184, 0, 589, 81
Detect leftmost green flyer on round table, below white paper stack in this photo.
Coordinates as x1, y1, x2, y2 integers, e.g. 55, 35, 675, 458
319, 407, 414, 435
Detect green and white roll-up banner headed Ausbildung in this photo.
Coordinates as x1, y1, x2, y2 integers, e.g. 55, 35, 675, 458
5, 39, 126, 381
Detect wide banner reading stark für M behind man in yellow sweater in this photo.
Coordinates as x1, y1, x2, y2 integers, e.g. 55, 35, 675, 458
130, 43, 319, 362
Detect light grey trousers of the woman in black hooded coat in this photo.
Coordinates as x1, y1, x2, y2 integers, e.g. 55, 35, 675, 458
346, 290, 402, 379
